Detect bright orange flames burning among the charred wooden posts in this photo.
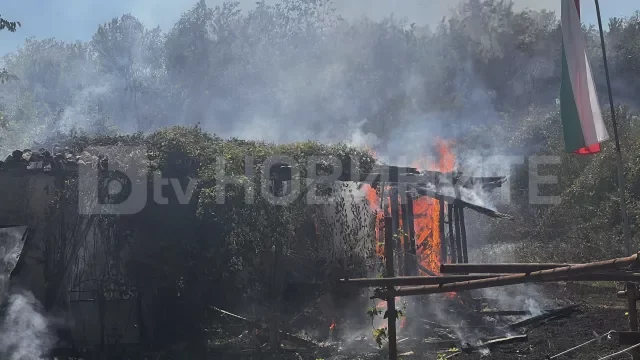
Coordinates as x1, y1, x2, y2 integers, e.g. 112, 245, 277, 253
366, 139, 456, 273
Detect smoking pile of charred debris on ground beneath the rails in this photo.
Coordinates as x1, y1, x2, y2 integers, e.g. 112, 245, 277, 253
208, 286, 580, 358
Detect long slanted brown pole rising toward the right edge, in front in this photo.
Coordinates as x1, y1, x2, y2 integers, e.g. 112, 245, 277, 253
376, 254, 638, 297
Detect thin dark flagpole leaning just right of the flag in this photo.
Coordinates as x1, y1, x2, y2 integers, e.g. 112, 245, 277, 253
595, 0, 632, 255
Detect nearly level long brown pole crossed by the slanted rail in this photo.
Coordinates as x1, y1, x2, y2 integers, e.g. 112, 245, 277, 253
338, 271, 640, 288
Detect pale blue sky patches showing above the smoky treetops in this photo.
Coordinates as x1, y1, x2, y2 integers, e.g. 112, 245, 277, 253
0, 0, 640, 55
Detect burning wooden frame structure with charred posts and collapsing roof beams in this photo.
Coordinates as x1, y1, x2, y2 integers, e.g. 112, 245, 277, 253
366, 140, 512, 275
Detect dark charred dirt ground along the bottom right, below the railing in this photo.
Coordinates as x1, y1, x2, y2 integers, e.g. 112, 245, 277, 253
212, 283, 630, 360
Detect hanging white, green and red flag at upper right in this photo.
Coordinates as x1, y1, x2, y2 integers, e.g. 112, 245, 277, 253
560, 0, 609, 154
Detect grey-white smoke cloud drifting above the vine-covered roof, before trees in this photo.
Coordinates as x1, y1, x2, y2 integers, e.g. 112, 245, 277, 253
0, 1, 552, 157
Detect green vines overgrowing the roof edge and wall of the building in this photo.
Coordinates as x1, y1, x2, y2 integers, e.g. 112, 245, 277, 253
41, 127, 374, 352
